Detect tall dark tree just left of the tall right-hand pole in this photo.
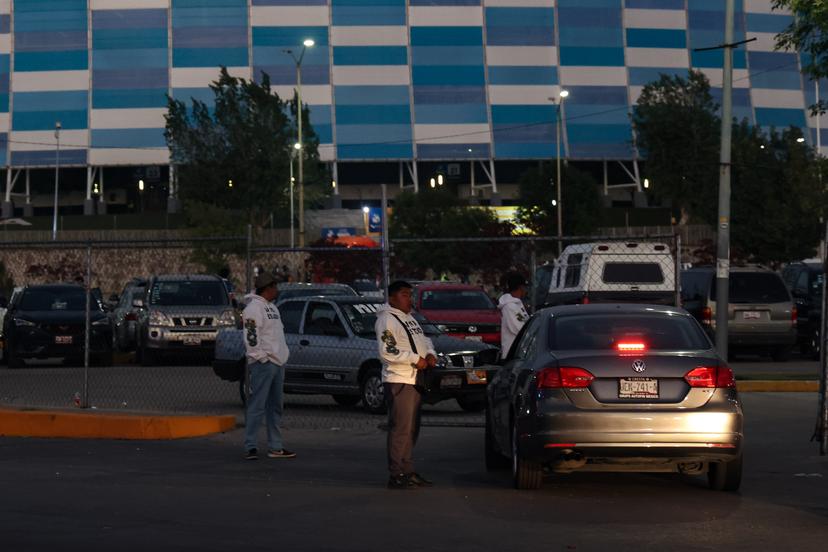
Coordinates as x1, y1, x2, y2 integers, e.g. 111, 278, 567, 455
632, 70, 721, 224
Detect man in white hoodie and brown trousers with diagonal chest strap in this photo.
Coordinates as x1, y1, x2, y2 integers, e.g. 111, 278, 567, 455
374, 280, 437, 489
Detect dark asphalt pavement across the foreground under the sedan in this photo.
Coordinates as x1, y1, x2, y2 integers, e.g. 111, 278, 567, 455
0, 393, 828, 552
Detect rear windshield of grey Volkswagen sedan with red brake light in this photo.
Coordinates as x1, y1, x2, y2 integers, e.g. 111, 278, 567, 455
551, 313, 711, 351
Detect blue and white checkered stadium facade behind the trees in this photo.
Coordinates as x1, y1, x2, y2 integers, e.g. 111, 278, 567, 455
0, 0, 828, 211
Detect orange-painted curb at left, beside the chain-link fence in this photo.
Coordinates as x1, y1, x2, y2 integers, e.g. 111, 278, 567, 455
0, 410, 236, 440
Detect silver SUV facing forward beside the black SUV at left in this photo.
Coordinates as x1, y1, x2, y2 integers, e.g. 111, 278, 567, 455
132, 274, 240, 366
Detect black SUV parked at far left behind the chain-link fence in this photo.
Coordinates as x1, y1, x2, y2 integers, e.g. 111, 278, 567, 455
3, 284, 112, 368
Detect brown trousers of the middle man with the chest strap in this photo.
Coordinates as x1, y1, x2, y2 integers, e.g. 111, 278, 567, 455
383, 383, 420, 475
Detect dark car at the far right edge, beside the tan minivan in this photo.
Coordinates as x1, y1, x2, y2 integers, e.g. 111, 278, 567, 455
782, 261, 825, 359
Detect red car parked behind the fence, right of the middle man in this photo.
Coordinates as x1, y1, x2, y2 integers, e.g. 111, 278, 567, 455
414, 283, 500, 346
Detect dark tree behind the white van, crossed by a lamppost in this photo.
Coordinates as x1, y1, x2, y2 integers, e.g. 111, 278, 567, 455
516, 163, 603, 236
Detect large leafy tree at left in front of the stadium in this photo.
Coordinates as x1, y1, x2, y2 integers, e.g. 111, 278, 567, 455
164, 67, 327, 227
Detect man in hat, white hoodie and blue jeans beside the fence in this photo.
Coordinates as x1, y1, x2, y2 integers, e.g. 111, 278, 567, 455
242, 270, 296, 460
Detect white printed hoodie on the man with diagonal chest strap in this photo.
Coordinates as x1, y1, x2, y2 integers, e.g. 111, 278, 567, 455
374, 305, 437, 385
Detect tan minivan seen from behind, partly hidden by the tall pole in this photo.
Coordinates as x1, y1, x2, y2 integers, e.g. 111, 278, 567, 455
681, 266, 797, 361
